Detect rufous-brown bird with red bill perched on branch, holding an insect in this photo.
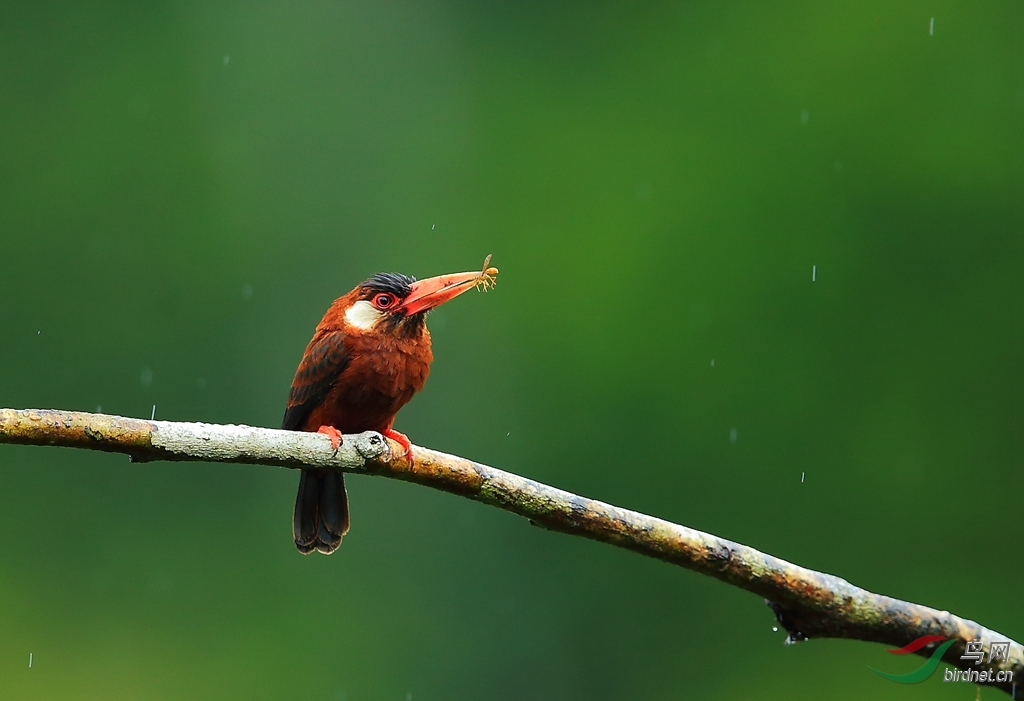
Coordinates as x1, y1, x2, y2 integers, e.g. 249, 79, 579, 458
282, 256, 498, 555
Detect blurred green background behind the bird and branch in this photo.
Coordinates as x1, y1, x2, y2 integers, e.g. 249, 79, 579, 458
0, 0, 1024, 701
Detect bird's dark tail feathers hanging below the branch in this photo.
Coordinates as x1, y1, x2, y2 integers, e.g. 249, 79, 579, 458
292, 470, 348, 555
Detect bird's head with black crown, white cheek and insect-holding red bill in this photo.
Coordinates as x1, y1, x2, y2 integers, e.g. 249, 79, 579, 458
343, 256, 498, 337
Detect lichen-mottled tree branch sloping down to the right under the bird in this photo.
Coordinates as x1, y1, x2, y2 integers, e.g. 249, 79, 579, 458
0, 409, 1024, 695
